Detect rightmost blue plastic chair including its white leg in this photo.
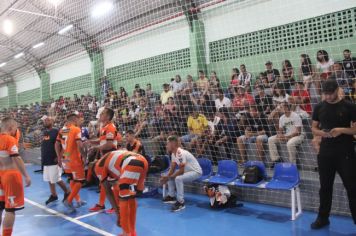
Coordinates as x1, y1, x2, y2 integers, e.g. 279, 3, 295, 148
265, 163, 302, 220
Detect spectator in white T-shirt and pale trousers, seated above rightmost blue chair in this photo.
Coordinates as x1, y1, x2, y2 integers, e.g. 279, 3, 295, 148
268, 102, 304, 163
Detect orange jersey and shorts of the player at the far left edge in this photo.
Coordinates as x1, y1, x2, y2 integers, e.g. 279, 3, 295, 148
0, 134, 25, 211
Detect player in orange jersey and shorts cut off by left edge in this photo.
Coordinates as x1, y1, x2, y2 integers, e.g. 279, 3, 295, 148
0, 118, 31, 236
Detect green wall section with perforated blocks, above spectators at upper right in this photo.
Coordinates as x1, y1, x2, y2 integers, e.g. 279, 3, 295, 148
208, 8, 356, 87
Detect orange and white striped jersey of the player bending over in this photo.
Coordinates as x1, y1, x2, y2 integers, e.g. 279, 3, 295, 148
95, 150, 148, 198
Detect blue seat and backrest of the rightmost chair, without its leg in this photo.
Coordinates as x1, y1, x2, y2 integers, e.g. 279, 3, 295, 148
266, 163, 300, 190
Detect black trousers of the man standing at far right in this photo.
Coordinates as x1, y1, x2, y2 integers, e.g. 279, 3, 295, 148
318, 153, 356, 224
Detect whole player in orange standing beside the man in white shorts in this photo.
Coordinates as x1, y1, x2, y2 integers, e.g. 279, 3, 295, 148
56, 114, 85, 213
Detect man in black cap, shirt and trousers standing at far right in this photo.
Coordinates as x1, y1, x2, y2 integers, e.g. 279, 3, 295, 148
311, 80, 356, 229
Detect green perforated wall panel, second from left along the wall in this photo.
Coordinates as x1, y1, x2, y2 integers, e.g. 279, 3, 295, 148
51, 74, 93, 99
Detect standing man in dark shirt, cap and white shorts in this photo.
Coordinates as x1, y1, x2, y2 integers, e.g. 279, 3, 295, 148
41, 116, 69, 205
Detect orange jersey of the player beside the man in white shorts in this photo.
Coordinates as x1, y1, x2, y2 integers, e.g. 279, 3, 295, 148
57, 125, 83, 168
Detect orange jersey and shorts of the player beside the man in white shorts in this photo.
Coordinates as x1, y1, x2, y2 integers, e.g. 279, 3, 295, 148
57, 125, 85, 180
